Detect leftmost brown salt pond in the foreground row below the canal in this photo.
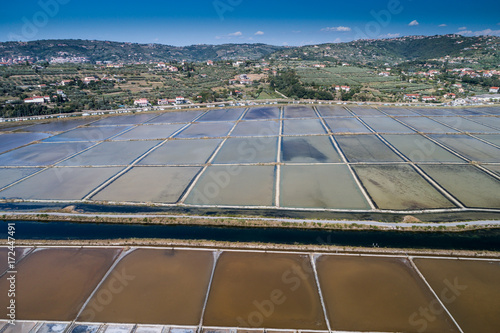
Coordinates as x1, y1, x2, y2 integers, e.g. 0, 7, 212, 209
0, 248, 120, 321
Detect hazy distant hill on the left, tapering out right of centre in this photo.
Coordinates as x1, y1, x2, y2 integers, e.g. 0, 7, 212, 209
0, 39, 282, 63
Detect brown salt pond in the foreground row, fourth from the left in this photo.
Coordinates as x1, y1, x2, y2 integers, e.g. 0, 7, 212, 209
317, 255, 458, 332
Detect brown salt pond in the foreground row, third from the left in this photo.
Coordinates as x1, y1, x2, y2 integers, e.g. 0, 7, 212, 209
203, 252, 326, 329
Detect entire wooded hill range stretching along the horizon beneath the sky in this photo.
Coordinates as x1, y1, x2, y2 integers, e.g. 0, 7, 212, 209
0, 35, 500, 65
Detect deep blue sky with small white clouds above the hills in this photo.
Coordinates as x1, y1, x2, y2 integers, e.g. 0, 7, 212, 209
0, 0, 500, 46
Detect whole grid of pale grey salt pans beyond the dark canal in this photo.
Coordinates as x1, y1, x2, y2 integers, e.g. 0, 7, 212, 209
0, 105, 500, 214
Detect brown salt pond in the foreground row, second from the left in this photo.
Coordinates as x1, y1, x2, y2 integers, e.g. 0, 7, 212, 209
79, 249, 213, 325
